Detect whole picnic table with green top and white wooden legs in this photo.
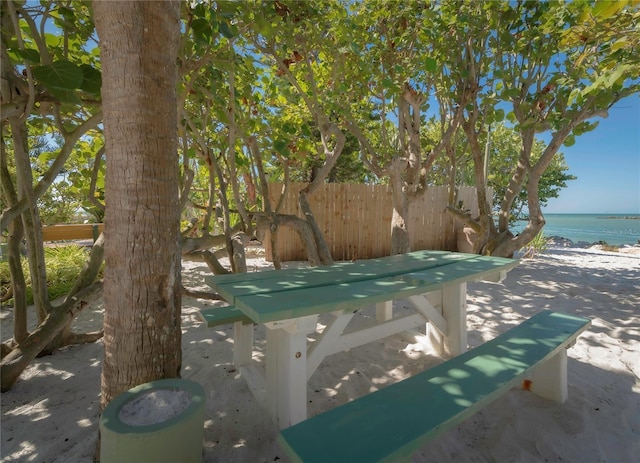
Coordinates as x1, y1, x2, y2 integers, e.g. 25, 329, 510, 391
201, 251, 518, 429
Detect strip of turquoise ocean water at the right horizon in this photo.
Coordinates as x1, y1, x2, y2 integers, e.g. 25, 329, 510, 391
513, 213, 640, 246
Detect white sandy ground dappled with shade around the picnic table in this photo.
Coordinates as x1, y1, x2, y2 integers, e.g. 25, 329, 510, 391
0, 248, 640, 463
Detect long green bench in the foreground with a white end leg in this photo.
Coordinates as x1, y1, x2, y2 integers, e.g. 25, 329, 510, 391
278, 311, 591, 463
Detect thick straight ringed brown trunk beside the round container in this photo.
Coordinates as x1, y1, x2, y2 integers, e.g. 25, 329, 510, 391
93, 0, 182, 407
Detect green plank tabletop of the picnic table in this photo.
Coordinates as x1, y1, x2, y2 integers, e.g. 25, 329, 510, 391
206, 251, 517, 323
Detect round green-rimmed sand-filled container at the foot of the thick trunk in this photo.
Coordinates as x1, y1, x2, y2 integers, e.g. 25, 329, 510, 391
100, 378, 205, 463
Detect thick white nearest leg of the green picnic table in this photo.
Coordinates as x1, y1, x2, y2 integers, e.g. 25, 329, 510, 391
266, 315, 318, 429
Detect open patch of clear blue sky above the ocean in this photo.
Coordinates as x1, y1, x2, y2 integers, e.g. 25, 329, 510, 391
543, 95, 640, 214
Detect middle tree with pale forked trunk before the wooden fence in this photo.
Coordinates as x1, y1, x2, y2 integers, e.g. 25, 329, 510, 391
331, 1, 462, 253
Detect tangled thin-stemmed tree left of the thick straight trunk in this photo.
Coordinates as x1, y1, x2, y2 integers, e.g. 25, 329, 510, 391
0, 1, 102, 391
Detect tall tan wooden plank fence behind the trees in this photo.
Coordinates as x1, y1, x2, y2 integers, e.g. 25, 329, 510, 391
264, 183, 478, 261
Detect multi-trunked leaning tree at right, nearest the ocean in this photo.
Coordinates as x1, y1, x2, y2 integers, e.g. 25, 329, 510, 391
441, 1, 640, 256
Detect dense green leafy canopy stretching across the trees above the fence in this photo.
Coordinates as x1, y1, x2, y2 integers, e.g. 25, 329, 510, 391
2, 1, 638, 243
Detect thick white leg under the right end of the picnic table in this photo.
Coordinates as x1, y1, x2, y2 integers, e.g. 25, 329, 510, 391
442, 282, 467, 356
